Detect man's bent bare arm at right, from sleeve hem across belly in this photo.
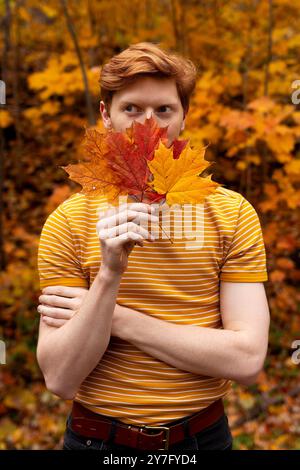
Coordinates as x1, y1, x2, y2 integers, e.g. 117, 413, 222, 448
112, 281, 270, 385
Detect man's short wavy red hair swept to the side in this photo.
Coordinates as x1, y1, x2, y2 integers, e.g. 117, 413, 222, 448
99, 42, 197, 114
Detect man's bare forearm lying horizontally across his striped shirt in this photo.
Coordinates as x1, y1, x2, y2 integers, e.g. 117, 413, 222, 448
115, 305, 258, 384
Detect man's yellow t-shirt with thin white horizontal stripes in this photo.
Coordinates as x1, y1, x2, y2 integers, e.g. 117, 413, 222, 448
38, 186, 268, 425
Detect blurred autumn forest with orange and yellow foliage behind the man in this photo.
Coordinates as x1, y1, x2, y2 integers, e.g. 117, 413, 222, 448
0, 0, 300, 450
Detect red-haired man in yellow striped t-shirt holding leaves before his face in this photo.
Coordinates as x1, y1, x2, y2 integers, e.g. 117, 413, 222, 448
37, 43, 269, 453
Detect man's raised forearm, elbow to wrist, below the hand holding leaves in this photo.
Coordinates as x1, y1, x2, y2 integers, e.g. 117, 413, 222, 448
37, 270, 121, 399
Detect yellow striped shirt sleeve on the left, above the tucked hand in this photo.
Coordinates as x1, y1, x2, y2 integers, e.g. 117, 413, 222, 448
38, 204, 88, 289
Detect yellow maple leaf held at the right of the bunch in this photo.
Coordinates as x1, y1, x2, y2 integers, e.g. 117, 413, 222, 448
147, 142, 220, 205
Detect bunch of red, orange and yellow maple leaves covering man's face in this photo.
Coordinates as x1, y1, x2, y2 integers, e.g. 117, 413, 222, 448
60, 116, 220, 241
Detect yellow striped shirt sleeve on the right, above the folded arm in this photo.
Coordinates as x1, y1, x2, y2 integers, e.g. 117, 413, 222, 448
220, 197, 268, 282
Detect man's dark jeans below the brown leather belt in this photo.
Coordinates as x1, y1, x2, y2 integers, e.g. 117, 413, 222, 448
63, 414, 233, 454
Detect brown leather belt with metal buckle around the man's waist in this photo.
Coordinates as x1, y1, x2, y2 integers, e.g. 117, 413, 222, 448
70, 398, 224, 450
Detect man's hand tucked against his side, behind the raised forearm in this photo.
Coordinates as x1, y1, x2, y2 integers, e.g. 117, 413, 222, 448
37, 286, 88, 328
